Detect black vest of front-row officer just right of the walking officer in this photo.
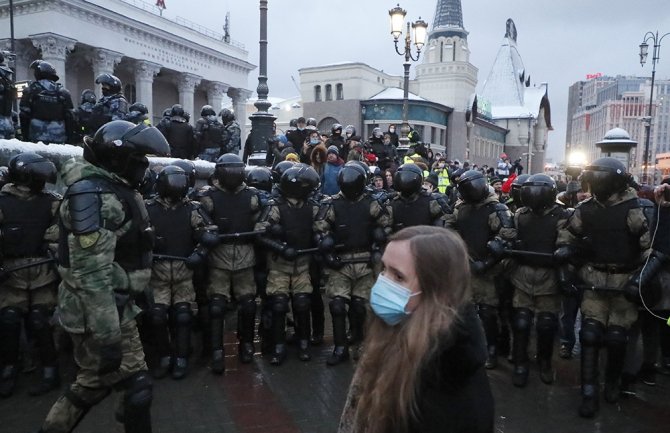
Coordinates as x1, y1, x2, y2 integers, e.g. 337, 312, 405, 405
147, 201, 195, 257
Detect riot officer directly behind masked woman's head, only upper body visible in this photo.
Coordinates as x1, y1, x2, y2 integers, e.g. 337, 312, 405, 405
388, 163, 451, 232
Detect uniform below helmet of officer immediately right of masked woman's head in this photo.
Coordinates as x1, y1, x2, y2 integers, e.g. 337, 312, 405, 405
445, 192, 516, 368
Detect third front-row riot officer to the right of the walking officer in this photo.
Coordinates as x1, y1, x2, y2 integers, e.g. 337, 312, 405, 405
255, 164, 320, 365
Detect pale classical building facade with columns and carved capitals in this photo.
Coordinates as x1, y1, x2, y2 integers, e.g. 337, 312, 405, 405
0, 0, 255, 123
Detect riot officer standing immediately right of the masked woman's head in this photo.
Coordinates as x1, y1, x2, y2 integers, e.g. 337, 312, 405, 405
445, 170, 516, 369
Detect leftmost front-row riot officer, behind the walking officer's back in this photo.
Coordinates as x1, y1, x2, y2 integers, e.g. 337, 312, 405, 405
0, 152, 60, 397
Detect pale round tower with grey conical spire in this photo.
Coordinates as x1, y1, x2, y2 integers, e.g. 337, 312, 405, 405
416, 0, 478, 154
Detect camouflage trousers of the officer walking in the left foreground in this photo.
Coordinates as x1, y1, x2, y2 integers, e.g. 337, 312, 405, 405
42, 320, 147, 433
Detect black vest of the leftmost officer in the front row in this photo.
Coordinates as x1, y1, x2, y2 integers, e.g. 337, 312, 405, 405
0, 193, 54, 258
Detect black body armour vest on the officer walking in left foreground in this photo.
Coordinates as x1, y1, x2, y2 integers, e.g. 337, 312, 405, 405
58, 178, 153, 272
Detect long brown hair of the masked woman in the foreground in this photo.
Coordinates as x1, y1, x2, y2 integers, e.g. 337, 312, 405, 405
354, 226, 470, 433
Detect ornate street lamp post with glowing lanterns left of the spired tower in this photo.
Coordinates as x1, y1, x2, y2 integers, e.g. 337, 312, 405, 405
389, 4, 428, 145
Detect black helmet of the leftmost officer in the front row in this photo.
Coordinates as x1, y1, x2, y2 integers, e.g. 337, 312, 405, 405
7, 152, 56, 192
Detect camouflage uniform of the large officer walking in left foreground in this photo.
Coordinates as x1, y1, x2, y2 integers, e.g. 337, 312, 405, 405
42, 160, 152, 432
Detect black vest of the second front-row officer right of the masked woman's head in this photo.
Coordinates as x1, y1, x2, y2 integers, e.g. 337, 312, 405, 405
517, 206, 566, 267
